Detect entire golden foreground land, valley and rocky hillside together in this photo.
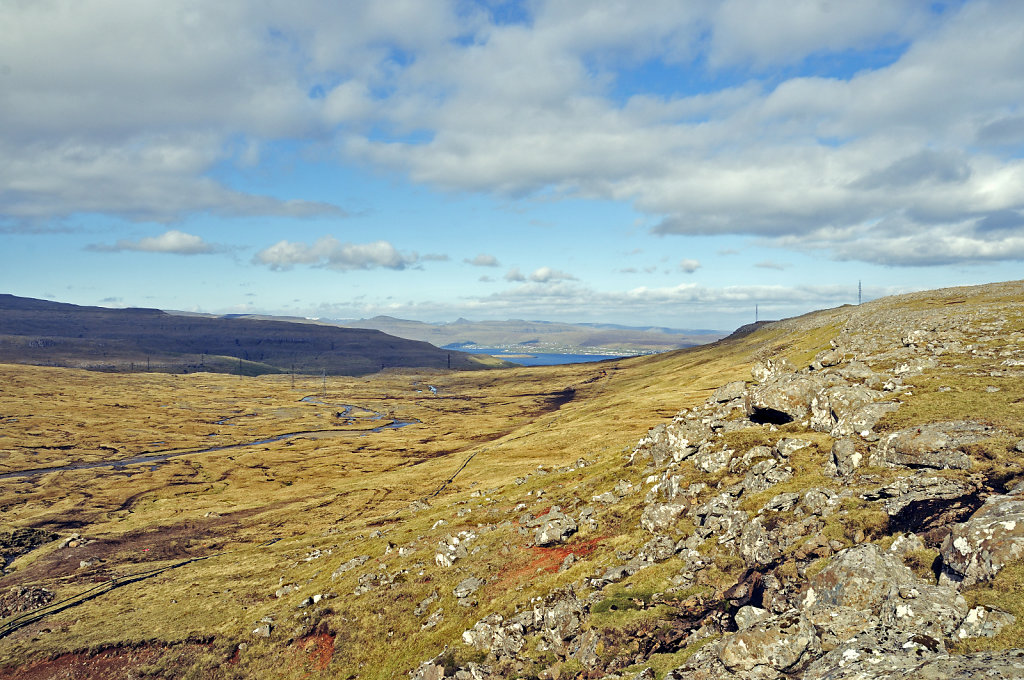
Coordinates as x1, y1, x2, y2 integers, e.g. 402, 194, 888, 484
6, 283, 1024, 680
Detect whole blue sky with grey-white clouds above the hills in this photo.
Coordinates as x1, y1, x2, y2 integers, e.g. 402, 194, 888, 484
0, 0, 1024, 330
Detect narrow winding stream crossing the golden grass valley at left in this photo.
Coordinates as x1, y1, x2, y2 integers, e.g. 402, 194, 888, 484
0, 396, 423, 479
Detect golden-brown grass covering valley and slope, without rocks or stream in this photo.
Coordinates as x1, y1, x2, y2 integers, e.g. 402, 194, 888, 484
0, 278, 1024, 677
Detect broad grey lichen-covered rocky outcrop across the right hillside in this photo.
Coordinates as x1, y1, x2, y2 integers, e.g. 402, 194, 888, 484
411, 292, 1024, 680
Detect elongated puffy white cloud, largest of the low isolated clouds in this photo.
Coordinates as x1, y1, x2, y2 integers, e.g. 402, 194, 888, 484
253, 236, 420, 271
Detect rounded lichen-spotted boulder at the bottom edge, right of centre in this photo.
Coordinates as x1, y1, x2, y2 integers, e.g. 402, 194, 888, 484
719, 610, 821, 673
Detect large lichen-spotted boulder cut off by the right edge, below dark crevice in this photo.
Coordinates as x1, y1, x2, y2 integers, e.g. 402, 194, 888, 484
941, 485, 1024, 586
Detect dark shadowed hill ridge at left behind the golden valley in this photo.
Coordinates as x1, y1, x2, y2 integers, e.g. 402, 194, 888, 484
0, 294, 504, 375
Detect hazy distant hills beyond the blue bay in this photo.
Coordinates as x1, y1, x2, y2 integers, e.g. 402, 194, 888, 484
334, 316, 728, 354
